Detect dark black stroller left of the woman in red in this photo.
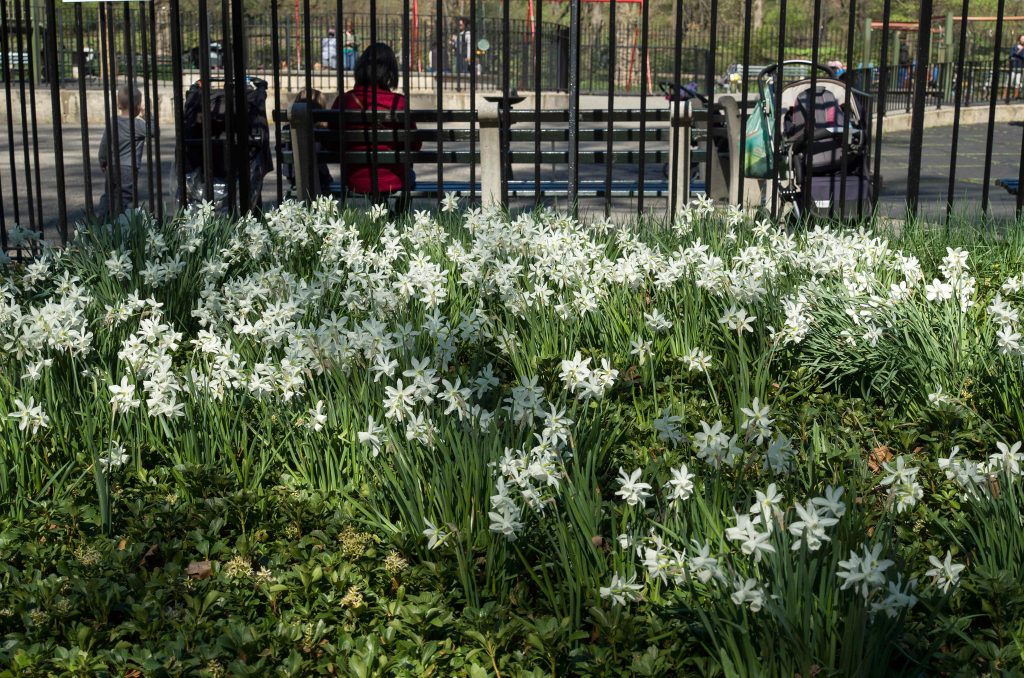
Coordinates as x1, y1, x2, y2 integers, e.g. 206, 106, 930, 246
180, 78, 273, 214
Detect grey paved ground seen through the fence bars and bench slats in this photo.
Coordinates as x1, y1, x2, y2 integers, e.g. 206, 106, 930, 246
0, 117, 1024, 236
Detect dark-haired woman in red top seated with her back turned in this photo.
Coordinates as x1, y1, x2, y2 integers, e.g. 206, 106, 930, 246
333, 42, 423, 212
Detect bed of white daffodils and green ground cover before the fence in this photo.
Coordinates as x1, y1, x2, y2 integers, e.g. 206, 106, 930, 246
0, 201, 1024, 676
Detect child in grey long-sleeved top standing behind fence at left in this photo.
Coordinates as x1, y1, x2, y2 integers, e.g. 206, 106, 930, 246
99, 85, 150, 218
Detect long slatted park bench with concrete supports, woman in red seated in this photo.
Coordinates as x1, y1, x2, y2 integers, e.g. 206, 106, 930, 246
274, 98, 739, 205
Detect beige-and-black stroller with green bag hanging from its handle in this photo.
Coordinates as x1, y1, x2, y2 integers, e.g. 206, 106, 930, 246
758, 60, 871, 219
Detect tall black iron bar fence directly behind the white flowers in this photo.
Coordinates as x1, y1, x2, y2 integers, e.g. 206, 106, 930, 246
0, 0, 1024, 251
